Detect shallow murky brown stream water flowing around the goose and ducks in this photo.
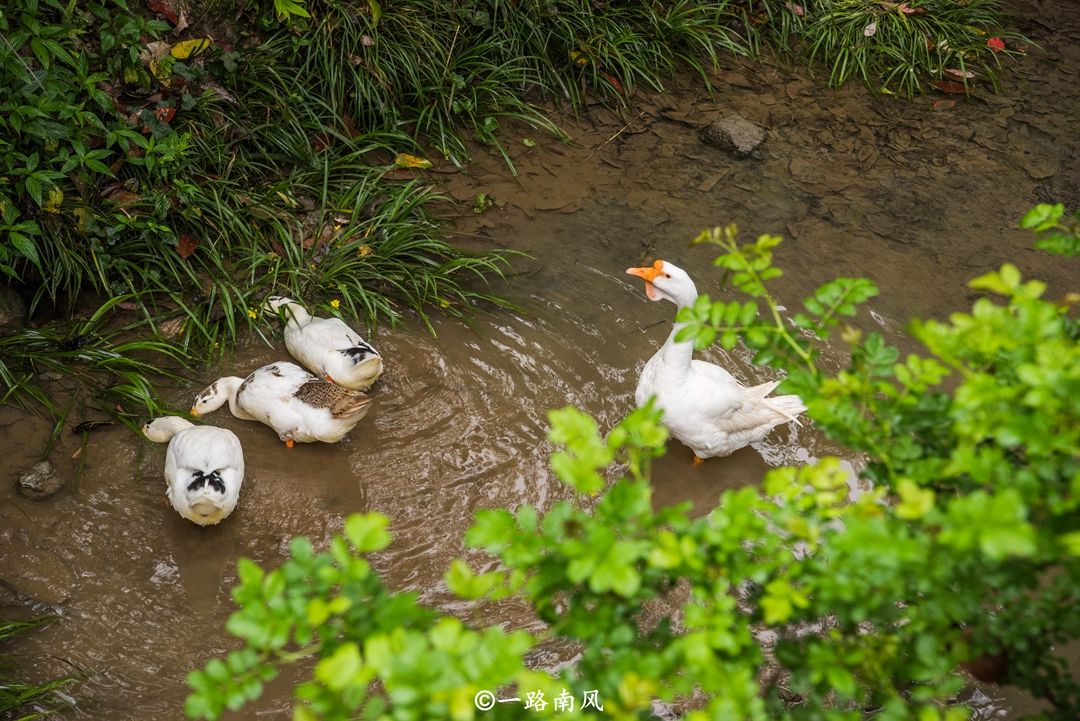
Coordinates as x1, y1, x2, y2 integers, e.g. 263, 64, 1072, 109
0, 2, 1080, 719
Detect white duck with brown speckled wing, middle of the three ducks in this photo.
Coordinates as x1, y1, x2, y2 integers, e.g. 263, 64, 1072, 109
191, 362, 372, 448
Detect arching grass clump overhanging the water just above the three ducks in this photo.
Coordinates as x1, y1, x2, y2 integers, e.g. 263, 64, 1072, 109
241, 168, 514, 328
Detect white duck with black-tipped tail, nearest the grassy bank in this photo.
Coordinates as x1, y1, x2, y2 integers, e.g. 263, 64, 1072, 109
264, 297, 382, 391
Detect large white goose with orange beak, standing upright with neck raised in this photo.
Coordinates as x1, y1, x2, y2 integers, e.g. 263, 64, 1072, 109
626, 260, 806, 463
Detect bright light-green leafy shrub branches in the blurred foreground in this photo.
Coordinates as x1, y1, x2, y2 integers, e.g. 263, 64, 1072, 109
187, 218, 1080, 721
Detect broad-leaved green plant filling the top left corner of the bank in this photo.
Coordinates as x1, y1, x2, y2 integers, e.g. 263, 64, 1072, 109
0, 0, 166, 291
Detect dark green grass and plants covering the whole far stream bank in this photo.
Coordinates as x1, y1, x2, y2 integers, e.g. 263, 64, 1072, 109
0, 0, 1013, 423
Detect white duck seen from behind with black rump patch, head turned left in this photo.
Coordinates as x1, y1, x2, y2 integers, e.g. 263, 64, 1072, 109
143, 416, 244, 526
